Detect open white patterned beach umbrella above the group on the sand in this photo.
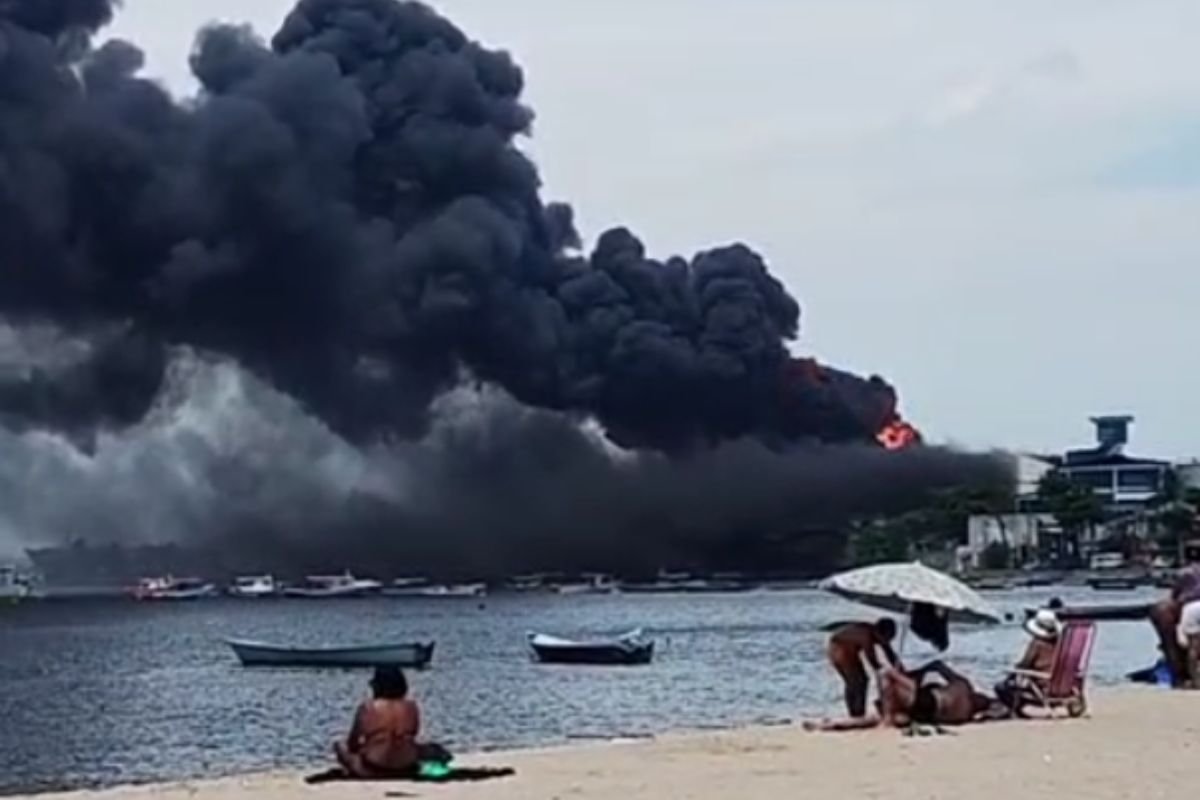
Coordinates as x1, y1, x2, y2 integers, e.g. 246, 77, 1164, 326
818, 561, 1001, 622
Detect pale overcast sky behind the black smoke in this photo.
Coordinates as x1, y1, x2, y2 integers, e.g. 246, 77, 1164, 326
110, 0, 1200, 457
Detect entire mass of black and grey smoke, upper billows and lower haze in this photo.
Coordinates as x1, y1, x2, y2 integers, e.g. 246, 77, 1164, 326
0, 0, 1007, 571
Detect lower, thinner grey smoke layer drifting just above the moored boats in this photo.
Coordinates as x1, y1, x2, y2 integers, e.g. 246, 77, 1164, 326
0, 353, 1009, 579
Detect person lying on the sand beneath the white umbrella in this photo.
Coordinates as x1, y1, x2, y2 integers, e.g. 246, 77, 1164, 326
804, 661, 1008, 730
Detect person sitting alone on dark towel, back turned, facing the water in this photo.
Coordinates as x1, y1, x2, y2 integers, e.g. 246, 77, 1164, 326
334, 667, 451, 778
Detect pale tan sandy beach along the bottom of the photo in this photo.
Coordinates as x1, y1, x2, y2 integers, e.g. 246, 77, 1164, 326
21, 688, 1200, 800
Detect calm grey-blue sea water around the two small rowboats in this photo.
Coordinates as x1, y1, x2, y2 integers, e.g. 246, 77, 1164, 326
0, 589, 1156, 793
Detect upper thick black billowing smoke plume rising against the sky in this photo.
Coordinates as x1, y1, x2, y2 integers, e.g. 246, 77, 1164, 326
0, 0, 894, 450
